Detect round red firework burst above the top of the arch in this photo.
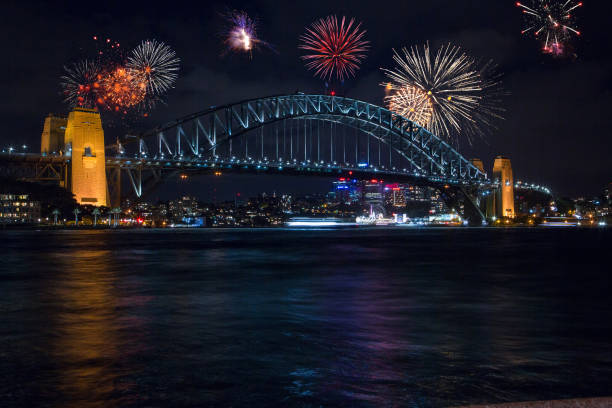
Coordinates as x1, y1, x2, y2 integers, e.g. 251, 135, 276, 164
300, 15, 370, 81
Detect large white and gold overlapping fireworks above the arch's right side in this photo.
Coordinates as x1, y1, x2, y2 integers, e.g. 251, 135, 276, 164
383, 44, 503, 142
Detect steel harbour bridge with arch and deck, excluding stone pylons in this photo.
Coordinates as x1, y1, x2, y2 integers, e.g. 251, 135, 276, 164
0, 93, 548, 224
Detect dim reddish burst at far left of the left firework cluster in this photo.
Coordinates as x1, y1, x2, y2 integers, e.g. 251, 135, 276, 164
60, 60, 102, 108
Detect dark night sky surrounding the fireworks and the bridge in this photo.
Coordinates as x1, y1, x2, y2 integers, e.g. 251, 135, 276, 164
0, 0, 612, 198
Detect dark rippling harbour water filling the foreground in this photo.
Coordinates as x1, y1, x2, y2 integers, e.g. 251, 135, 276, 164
0, 229, 612, 407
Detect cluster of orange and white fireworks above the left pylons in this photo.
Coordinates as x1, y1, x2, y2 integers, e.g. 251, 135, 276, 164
61, 37, 180, 116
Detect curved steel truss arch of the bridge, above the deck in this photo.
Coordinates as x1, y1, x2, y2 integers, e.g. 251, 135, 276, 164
119, 94, 487, 184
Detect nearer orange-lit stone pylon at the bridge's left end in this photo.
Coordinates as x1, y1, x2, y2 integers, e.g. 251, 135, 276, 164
64, 108, 107, 207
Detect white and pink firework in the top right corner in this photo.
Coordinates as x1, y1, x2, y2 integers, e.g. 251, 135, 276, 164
516, 0, 582, 55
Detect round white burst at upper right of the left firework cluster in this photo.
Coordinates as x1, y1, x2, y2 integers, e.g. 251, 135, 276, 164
126, 40, 181, 95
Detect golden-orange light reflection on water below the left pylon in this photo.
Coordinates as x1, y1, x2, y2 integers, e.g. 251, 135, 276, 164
50, 248, 129, 408
